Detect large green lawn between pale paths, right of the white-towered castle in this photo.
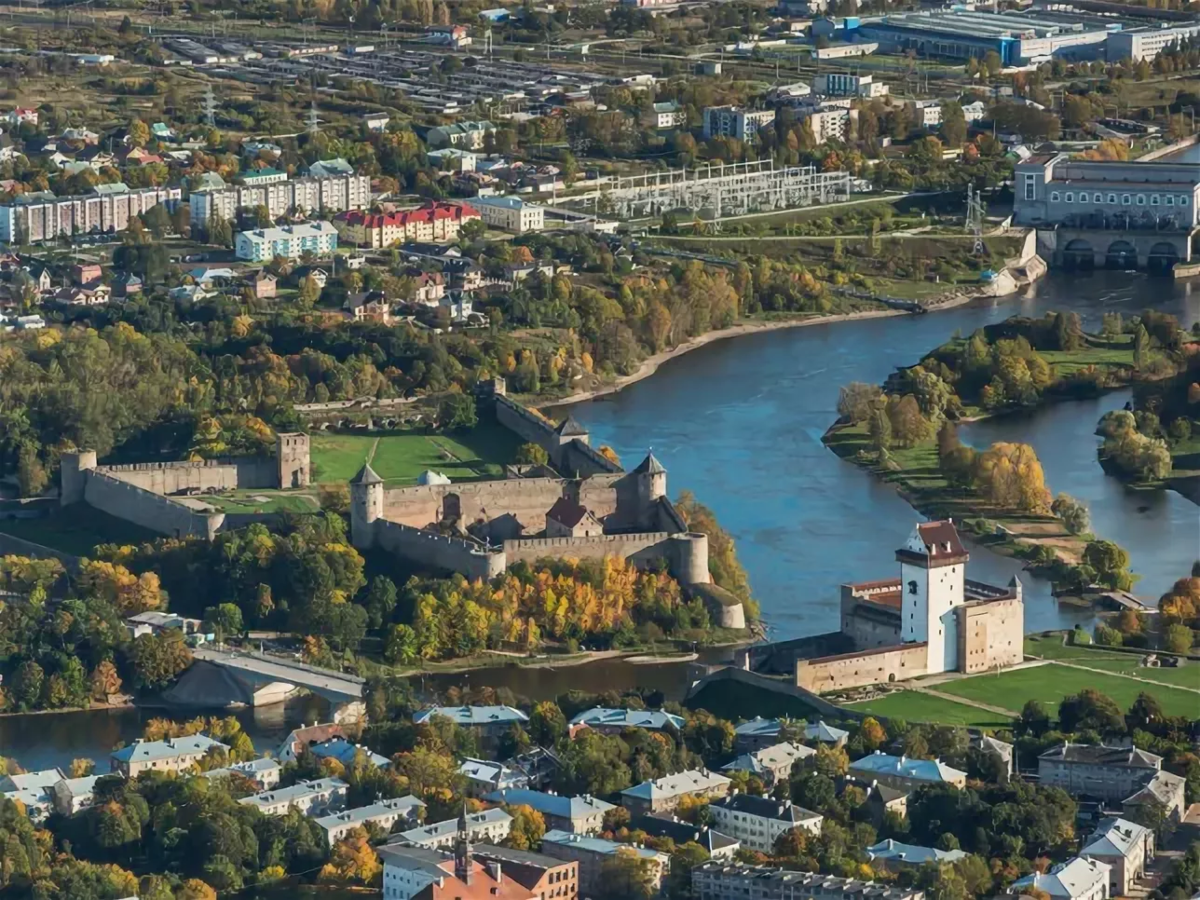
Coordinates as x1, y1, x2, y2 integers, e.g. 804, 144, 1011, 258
937, 662, 1200, 718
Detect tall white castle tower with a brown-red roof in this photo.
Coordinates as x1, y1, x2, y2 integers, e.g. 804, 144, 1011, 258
896, 520, 970, 674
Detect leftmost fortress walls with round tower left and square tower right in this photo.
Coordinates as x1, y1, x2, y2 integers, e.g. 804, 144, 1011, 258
60, 432, 311, 540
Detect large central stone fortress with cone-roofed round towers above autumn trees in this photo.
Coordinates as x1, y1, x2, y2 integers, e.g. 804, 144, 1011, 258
350, 378, 745, 628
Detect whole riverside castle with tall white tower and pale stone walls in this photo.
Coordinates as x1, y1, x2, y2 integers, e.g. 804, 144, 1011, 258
738, 520, 1025, 694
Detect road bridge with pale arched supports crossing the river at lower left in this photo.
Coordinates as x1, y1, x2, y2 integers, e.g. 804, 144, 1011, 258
163, 647, 366, 721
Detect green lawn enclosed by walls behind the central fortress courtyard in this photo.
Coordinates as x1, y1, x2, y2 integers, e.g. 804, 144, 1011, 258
312, 422, 520, 485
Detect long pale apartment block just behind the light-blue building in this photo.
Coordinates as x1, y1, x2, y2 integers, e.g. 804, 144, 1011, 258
188, 173, 371, 228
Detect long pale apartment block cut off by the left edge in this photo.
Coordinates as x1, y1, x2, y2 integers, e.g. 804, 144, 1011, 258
0, 182, 184, 244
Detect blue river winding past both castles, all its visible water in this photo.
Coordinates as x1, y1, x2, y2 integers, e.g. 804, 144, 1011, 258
0, 271, 1200, 768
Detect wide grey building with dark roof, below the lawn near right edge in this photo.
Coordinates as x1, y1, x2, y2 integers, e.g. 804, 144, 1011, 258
1038, 740, 1163, 803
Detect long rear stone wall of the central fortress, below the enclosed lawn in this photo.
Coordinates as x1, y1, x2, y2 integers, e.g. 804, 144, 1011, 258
383, 478, 563, 534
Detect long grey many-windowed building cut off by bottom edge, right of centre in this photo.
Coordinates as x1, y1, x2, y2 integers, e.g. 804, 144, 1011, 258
691, 859, 925, 900
